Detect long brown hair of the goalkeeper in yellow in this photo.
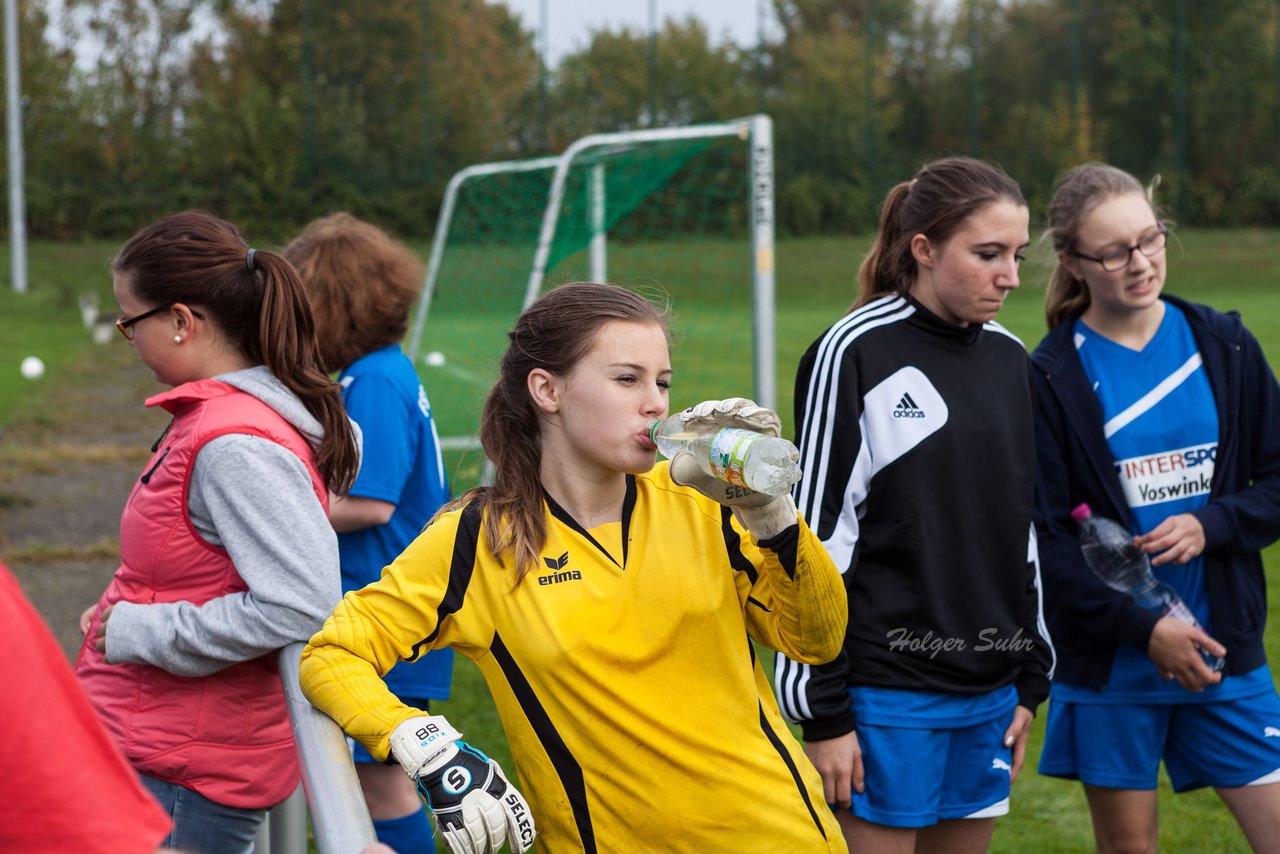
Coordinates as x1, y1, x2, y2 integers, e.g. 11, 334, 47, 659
436, 282, 671, 584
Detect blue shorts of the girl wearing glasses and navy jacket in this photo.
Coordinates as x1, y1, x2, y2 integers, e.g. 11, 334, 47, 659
1039, 688, 1280, 791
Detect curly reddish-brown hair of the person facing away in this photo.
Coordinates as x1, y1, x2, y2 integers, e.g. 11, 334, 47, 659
284, 214, 426, 373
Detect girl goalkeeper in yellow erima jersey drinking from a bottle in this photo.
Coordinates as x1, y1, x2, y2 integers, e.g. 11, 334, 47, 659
302, 284, 845, 854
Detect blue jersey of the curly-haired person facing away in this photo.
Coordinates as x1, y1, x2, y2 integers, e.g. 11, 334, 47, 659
338, 344, 453, 699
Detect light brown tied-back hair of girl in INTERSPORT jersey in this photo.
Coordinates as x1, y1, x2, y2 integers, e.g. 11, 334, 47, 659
1044, 163, 1160, 329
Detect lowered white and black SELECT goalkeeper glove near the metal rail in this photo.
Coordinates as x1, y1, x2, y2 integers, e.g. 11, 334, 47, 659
390, 714, 536, 854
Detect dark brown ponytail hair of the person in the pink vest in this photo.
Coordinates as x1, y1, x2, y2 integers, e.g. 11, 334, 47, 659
111, 211, 360, 494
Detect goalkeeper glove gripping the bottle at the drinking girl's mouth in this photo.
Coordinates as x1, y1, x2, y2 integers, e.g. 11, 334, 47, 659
671, 397, 797, 539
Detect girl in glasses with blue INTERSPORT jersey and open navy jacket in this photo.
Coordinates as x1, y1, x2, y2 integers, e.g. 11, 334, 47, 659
1033, 164, 1280, 851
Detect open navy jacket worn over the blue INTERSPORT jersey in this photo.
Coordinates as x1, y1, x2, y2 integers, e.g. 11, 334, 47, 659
1032, 294, 1280, 690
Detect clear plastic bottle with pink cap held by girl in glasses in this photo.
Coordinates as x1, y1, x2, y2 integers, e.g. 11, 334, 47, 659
1071, 504, 1225, 671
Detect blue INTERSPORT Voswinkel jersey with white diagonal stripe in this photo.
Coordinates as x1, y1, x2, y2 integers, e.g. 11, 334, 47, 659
1053, 302, 1270, 703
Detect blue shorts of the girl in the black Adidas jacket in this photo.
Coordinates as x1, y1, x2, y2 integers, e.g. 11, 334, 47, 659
852, 714, 1012, 827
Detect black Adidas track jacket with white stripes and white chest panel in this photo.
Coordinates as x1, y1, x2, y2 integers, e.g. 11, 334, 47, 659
774, 296, 1053, 740
